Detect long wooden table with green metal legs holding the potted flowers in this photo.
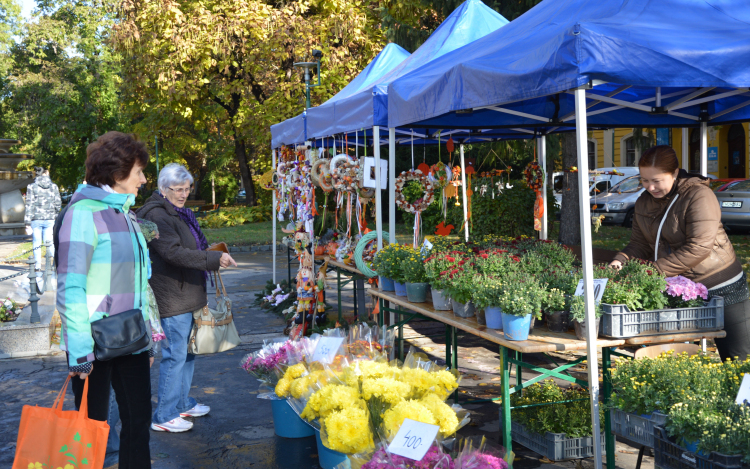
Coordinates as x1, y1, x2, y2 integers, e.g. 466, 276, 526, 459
369, 288, 726, 468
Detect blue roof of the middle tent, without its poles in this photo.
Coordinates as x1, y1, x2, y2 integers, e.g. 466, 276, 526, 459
307, 0, 508, 138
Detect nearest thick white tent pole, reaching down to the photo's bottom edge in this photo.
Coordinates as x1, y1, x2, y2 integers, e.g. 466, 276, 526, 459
575, 88, 614, 469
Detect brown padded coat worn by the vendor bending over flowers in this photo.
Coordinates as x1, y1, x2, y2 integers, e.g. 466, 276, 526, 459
615, 170, 742, 289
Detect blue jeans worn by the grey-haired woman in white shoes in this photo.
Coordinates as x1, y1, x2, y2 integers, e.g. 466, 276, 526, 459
153, 313, 197, 424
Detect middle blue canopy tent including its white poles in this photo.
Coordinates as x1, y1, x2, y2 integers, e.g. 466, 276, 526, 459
307, 0, 508, 247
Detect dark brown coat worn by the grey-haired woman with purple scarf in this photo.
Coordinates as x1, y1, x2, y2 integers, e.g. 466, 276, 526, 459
138, 192, 222, 318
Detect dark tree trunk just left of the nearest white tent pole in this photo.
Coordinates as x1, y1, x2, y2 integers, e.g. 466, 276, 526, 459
558, 132, 581, 246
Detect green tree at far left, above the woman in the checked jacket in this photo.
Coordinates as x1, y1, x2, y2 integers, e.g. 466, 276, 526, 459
0, 0, 120, 188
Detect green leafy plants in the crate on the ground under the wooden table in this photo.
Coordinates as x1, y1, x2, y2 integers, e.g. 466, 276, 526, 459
511, 379, 604, 438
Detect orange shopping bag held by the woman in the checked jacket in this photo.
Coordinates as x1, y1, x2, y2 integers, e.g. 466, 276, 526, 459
13, 376, 109, 469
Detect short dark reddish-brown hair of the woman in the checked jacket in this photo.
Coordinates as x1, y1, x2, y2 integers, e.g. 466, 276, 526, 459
86, 131, 148, 187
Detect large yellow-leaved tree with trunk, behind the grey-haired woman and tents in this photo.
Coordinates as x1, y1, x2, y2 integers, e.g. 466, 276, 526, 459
113, 0, 384, 205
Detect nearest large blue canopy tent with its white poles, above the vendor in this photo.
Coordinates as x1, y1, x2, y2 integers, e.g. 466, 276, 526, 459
388, 0, 750, 468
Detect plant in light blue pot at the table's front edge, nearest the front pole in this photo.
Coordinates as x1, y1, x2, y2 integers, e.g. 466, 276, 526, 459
497, 274, 545, 340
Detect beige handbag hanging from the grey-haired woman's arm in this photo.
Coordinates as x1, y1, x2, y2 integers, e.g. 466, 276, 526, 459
188, 272, 242, 355
